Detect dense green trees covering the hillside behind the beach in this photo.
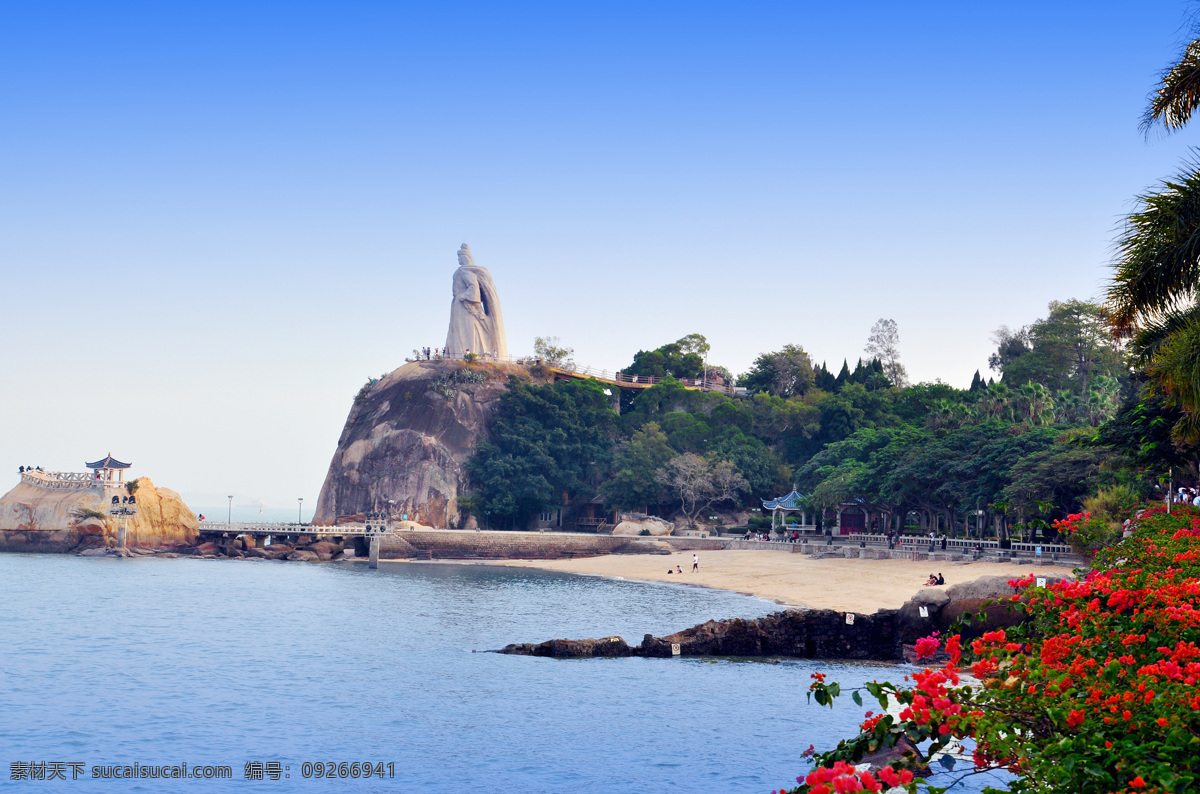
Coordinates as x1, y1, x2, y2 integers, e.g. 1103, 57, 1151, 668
469, 300, 1188, 537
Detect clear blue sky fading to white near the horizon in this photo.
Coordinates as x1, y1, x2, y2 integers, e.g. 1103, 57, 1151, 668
0, 0, 1194, 513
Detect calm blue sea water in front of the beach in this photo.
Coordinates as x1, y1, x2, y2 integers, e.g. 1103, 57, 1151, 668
0, 554, 996, 794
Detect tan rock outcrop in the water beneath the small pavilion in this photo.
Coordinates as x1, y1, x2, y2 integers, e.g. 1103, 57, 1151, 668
0, 477, 199, 552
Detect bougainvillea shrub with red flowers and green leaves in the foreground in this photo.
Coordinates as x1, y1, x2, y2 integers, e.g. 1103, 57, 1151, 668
772, 506, 1200, 794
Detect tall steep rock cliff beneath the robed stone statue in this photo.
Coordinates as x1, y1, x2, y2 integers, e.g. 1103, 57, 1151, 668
313, 361, 528, 528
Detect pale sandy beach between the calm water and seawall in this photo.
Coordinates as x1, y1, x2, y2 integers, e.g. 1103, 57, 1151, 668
470, 549, 1070, 613
